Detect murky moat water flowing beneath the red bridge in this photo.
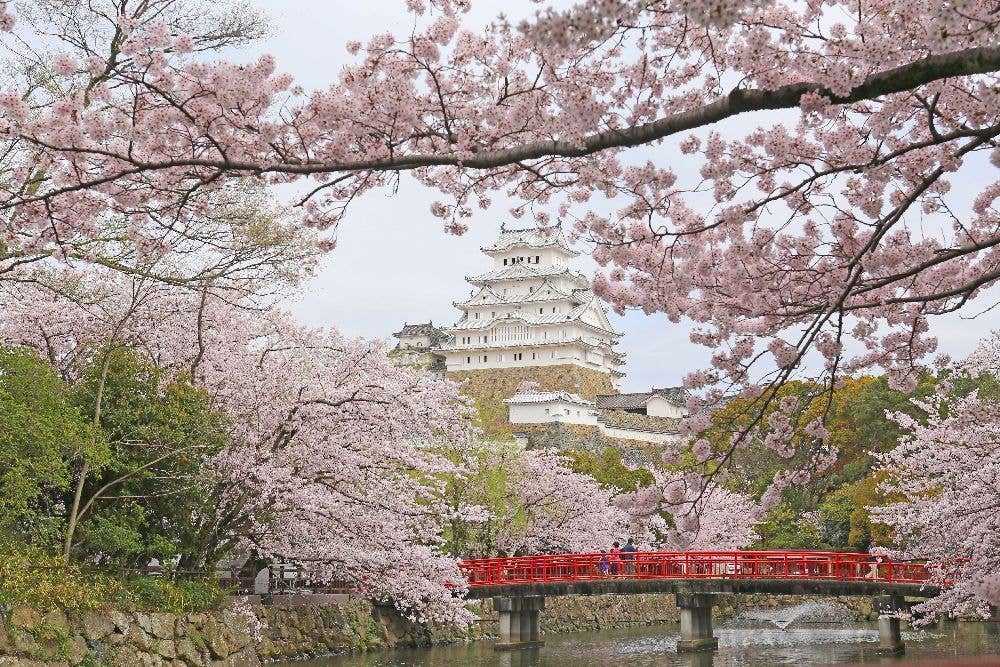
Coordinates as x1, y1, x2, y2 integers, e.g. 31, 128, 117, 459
274, 619, 1000, 667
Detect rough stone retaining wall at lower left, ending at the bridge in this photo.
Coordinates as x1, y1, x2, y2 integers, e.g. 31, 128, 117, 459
0, 596, 496, 667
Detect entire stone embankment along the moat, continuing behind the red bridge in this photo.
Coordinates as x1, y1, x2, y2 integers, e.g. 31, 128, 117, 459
0, 595, 892, 667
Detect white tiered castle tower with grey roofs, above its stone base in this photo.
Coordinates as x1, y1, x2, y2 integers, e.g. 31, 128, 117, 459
436, 228, 623, 383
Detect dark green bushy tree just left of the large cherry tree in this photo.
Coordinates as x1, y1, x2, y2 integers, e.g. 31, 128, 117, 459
67, 349, 226, 566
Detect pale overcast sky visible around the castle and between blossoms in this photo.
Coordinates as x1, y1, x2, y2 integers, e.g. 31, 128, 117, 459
235, 0, 1000, 391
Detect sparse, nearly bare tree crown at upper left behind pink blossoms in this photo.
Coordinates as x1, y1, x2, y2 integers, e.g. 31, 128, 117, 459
0, 0, 318, 292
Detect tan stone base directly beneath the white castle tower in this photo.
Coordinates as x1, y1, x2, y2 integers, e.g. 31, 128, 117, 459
448, 364, 618, 401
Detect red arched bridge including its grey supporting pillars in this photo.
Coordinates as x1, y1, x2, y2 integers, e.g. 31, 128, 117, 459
459, 551, 938, 653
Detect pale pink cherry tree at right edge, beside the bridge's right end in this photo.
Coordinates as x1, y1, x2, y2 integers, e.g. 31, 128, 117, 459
870, 333, 1000, 619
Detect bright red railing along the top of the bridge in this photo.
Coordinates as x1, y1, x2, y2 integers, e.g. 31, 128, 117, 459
460, 551, 930, 586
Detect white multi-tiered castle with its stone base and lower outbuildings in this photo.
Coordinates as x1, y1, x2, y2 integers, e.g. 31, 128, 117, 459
392, 227, 686, 444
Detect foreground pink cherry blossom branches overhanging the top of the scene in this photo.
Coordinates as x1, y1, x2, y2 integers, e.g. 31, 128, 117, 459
0, 0, 1000, 485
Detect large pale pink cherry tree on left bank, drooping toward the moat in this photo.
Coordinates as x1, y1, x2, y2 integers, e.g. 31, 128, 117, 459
0, 271, 484, 621
